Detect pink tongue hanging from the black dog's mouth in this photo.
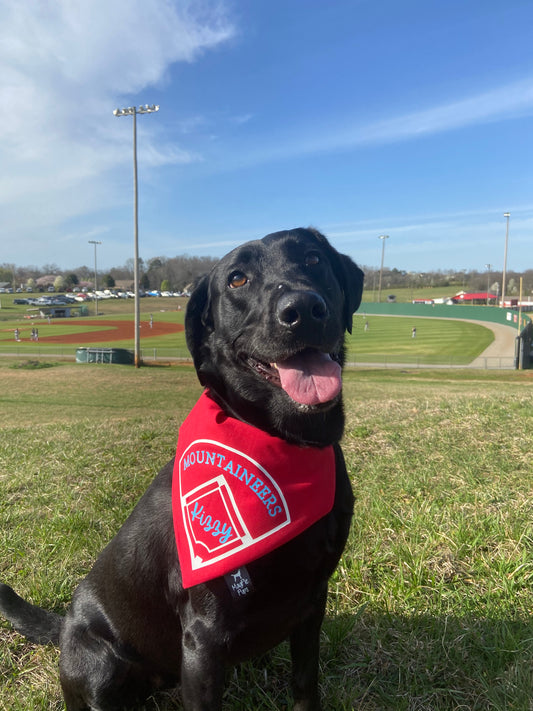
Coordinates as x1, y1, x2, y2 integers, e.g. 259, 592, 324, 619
276, 351, 342, 405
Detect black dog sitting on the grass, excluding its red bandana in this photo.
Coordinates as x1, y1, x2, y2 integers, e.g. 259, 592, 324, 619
0, 228, 363, 711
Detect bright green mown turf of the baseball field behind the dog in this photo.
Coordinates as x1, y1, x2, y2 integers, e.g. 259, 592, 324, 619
0, 297, 494, 365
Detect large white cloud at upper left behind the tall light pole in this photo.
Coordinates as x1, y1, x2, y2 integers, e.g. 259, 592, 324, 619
0, 0, 234, 250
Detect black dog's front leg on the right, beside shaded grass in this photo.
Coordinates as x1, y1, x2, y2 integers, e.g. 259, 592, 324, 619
290, 584, 327, 711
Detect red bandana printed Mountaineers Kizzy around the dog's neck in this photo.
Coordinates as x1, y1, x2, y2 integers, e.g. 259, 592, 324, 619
172, 392, 335, 588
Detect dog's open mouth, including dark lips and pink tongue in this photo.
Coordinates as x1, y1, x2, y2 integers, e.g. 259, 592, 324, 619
244, 348, 342, 407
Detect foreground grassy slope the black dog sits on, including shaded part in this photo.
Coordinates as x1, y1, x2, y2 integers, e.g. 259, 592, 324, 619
0, 358, 533, 711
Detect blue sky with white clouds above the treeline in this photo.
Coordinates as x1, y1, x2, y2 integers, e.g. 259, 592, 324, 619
0, 0, 533, 271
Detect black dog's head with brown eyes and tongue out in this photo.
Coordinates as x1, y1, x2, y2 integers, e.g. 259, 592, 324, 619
185, 228, 363, 445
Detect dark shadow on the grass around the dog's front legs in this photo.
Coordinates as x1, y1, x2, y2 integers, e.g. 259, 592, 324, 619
133, 612, 533, 711
